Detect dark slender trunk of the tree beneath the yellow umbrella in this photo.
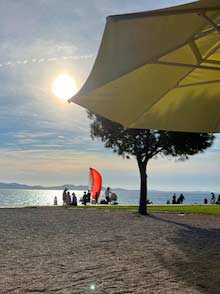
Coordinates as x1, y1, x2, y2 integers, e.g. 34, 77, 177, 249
137, 157, 147, 215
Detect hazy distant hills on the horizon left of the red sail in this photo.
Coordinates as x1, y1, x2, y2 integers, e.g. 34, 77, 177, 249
0, 183, 88, 190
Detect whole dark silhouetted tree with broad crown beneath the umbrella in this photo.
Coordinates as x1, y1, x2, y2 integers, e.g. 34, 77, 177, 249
88, 112, 215, 215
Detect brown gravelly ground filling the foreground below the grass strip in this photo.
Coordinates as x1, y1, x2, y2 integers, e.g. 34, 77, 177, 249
0, 207, 220, 294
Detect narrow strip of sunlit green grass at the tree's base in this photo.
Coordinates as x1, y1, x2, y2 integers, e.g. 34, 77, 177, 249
68, 205, 220, 215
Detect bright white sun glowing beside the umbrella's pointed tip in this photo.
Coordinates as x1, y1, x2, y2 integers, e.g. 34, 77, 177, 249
52, 74, 77, 100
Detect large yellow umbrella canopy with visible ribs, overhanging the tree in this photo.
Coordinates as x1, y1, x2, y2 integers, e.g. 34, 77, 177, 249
69, 0, 220, 132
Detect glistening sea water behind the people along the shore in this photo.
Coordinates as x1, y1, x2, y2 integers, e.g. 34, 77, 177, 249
0, 189, 215, 207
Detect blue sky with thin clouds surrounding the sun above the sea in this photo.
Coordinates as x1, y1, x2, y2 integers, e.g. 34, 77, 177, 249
0, 0, 220, 192
